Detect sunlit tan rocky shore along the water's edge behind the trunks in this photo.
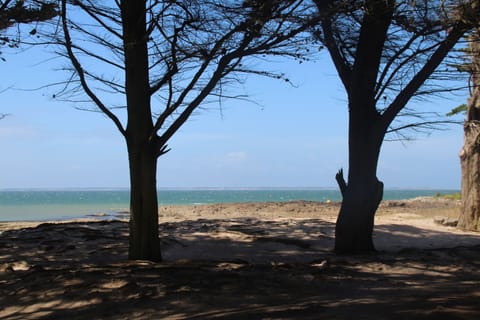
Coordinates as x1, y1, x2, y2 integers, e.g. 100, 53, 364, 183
0, 196, 460, 226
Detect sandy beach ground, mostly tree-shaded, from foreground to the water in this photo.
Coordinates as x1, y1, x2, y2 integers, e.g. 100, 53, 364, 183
0, 198, 480, 319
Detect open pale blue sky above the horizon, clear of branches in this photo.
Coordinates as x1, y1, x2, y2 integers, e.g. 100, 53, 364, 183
0, 41, 468, 189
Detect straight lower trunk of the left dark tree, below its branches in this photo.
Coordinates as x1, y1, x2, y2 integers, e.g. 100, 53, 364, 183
129, 147, 162, 261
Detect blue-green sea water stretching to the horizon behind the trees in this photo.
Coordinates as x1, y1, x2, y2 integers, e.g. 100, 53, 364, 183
0, 189, 458, 221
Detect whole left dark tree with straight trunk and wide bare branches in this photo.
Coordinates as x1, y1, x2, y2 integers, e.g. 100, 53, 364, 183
56, 0, 313, 261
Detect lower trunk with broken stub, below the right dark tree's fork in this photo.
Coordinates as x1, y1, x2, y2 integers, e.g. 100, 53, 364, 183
335, 111, 384, 254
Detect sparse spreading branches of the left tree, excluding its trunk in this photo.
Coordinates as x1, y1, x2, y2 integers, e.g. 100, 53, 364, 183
56, 0, 312, 142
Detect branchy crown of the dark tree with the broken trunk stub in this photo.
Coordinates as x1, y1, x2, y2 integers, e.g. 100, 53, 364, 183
315, 0, 478, 138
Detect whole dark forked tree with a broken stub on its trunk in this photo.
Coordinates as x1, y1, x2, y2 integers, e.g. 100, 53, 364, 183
314, 0, 480, 253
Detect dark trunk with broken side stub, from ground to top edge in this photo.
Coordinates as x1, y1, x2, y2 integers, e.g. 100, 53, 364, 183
329, 0, 395, 253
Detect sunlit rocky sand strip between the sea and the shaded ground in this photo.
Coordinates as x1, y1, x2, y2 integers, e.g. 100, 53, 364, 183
0, 197, 461, 232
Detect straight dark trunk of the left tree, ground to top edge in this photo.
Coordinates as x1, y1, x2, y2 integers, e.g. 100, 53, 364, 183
120, 0, 161, 261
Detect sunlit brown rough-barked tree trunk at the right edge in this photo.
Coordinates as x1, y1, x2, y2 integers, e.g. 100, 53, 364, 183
454, 28, 480, 231
